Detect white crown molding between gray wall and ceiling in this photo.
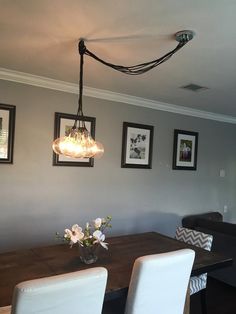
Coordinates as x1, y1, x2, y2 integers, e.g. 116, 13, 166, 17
0, 68, 236, 124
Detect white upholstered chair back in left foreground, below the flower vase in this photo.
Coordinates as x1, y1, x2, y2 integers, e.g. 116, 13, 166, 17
1, 267, 107, 314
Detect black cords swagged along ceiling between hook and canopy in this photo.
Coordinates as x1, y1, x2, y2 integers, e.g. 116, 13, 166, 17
79, 36, 190, 75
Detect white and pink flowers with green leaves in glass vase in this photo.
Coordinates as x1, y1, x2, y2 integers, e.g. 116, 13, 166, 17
57, 216, 111, 249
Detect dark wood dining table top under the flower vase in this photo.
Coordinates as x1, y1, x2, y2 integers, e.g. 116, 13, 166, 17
0, 232, 232, 306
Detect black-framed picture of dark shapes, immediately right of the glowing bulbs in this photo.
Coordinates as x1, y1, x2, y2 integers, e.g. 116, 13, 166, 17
121, 122, 154, 169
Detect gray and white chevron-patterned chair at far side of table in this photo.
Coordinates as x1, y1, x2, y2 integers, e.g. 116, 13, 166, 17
175, 227, 213, 314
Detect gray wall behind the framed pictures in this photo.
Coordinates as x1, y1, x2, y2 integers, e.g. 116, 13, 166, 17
0, 81, 236, 251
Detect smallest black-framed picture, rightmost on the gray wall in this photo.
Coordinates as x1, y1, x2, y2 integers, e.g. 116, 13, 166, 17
172, 130, 198, 170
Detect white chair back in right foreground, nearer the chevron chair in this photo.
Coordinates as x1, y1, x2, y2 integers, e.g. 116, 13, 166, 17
125, 249, 195, 314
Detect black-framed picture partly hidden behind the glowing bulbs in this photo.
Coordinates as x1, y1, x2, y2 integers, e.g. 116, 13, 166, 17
53, 112, 96, 167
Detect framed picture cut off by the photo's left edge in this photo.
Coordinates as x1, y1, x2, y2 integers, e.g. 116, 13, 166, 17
0, 104, 16, 164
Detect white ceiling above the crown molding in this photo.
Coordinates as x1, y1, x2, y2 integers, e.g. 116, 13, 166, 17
0, 0, 236, 117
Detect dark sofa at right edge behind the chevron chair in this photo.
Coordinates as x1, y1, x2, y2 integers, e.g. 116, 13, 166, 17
182, 212, 236, 287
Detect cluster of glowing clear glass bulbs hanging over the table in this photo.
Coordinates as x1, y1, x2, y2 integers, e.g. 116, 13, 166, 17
52, 127, 104, 158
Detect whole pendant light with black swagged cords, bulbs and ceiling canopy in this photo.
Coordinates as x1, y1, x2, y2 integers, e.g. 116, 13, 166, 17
52, 30, 195, 158
